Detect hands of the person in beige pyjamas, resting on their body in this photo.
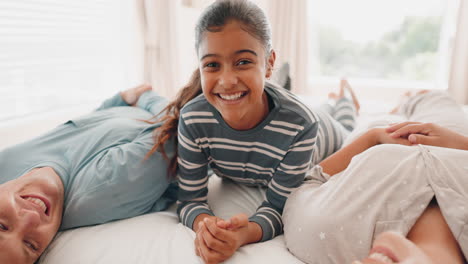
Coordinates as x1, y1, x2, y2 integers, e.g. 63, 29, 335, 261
387, 122, 468, 150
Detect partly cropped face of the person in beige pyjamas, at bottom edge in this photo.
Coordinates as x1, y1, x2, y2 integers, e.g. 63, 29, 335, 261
353, 232, 435, 264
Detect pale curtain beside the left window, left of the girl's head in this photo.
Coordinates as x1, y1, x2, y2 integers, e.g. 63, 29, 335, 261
144, 0, 180, 97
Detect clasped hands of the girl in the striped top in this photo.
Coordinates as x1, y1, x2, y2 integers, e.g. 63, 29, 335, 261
195, 214, 249, 263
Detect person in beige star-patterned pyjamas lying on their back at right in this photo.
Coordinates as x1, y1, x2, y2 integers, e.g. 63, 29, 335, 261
283, 89, 468, 264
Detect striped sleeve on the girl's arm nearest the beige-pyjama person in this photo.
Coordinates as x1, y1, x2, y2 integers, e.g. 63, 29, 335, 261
249, 122, 318, 241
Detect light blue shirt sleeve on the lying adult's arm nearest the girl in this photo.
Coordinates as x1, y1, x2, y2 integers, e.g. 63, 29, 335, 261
61, 130, 174, 230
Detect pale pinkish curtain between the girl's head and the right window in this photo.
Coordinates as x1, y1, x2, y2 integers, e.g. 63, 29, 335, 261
256, 0, 309, 93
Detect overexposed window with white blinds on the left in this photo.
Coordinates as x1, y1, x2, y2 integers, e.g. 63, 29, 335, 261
0, 0, 143, 120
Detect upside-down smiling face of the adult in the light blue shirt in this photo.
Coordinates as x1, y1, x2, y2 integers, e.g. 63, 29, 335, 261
0, 168, 64, 263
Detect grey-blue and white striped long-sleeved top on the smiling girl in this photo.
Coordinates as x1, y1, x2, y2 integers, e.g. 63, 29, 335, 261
177, 84, 318, 241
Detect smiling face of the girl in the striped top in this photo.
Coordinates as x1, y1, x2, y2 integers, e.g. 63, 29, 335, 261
198, 21, 275, 130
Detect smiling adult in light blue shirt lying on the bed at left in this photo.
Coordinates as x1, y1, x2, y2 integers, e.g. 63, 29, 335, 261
0, 86, 176, 263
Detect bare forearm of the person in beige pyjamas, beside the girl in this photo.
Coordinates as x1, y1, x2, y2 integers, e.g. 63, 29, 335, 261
319, 129, 378, 176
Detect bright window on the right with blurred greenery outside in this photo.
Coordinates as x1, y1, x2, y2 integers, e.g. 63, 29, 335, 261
308, 0, 458, 89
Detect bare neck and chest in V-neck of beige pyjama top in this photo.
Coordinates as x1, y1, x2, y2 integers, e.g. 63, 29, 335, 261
407, 199, 464, 264
